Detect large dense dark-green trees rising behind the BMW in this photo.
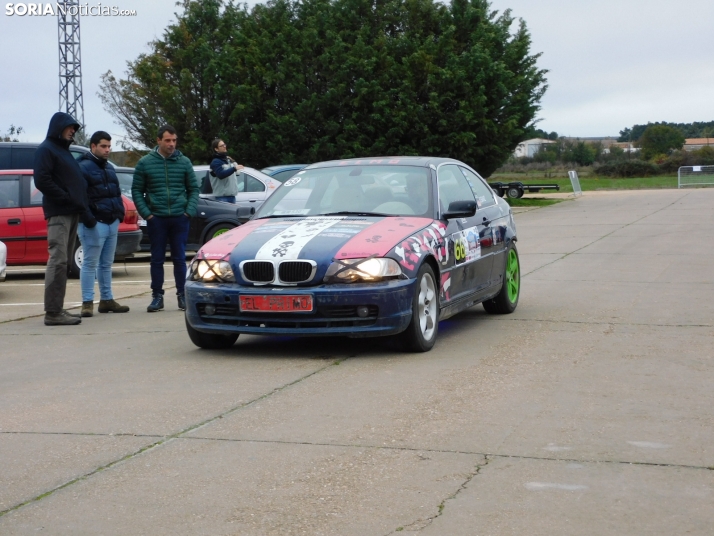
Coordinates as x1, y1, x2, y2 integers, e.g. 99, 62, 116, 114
99, 0, 547, 176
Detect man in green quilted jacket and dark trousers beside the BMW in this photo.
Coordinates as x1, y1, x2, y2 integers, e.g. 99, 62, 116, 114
131, 125, 198, 313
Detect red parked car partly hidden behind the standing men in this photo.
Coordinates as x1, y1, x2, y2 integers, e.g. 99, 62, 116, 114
0, 169, 142, 277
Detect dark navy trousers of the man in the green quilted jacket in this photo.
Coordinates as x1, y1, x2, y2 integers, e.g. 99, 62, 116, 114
146, 215, 191, 294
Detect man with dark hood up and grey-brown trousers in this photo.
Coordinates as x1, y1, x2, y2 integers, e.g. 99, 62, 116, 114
34, 112, 97, 326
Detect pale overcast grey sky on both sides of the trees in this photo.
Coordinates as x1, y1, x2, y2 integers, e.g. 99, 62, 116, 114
0, 0, 714, 141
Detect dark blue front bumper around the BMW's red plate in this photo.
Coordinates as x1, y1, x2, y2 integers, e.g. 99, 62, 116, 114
186, 279, 415, 337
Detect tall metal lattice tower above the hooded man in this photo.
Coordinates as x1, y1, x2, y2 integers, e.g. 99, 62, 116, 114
57, 0, 84, 127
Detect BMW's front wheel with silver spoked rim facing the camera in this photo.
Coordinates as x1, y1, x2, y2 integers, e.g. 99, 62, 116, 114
400, 263, 439, 352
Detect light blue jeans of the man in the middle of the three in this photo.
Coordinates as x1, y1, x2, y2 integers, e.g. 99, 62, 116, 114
77, 220, 119, 301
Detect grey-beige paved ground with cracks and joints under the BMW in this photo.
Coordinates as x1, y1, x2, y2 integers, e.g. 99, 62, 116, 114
0, 189, 714, 536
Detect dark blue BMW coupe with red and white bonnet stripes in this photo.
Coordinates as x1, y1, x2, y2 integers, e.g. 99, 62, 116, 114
186, 157, 520, 352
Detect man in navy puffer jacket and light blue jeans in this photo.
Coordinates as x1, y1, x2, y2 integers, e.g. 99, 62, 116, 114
77, 130, 129, 317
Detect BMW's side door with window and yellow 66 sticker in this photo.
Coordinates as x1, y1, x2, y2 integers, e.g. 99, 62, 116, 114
437, 164, 491, 301
